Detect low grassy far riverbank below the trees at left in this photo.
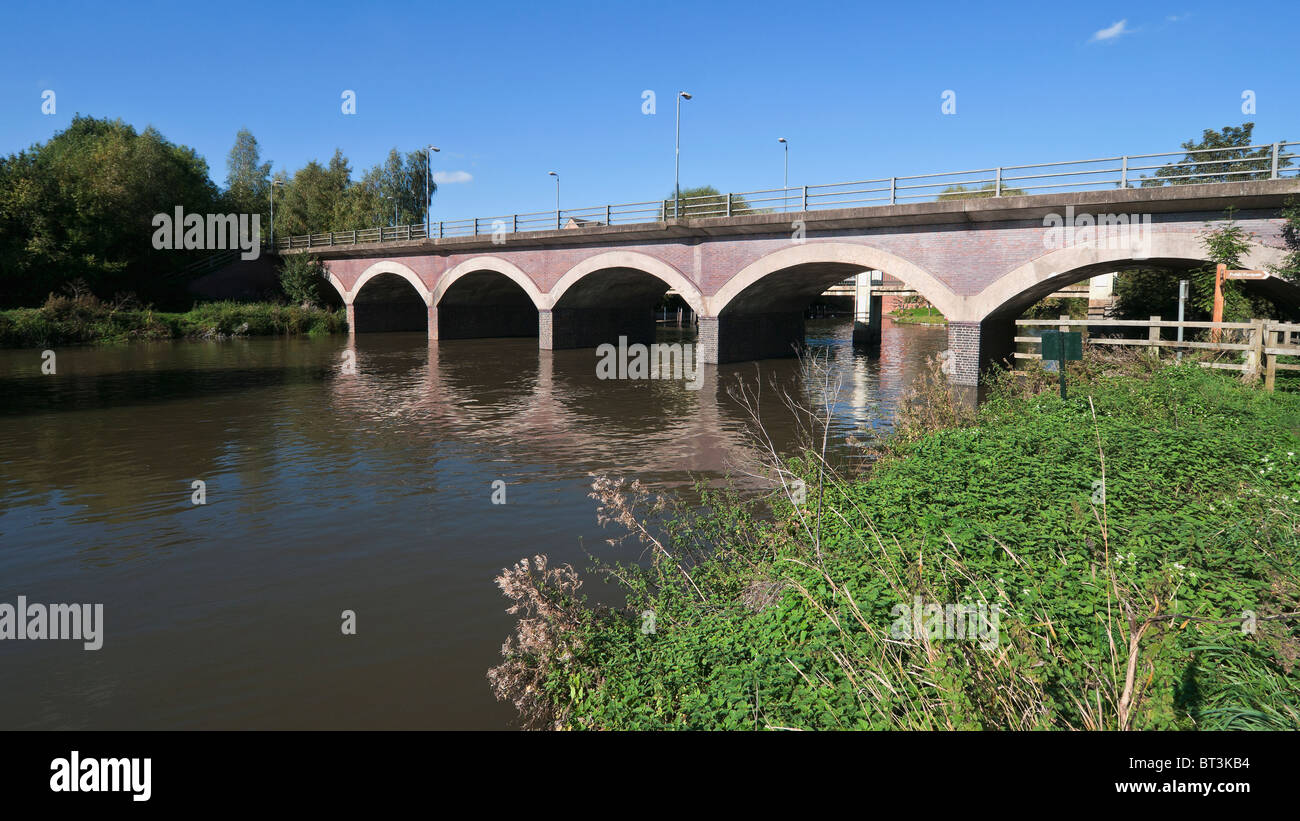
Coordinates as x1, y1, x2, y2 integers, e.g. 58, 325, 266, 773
0, 296, 347, 348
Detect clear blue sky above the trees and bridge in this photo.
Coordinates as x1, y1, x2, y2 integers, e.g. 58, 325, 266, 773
0, 0, 1300, 220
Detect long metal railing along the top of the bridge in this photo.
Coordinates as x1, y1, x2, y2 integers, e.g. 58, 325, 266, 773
276, 142, 1300, 249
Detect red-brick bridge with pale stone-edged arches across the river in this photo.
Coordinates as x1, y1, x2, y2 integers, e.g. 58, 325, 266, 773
295, 179, 1300, 385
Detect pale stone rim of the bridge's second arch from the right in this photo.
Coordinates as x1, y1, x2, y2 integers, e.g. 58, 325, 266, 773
709, 242, 961, 316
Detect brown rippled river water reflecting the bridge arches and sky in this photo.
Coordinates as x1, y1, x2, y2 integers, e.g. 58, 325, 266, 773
0, 321, 946, 729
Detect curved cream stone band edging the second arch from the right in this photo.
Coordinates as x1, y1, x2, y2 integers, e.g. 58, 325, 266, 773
709, 242, 962, 317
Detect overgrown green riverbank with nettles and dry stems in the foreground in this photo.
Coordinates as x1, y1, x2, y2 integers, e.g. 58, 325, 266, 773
489, 365, 1300, 730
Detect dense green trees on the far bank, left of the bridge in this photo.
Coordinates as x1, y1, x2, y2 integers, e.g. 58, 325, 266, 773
0, 117, 437, 308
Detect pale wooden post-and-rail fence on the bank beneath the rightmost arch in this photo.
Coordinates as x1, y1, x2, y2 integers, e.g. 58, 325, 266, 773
1015, 317, 1300, 391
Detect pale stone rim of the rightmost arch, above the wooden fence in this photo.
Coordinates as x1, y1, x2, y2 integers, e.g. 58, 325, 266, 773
967, 231, 1295, 321
